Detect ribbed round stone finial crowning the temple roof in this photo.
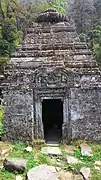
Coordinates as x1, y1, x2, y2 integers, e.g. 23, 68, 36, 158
36, 9, 68, 23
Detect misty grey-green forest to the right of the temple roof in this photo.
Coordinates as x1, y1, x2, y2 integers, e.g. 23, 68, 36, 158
69, 0, 101, 64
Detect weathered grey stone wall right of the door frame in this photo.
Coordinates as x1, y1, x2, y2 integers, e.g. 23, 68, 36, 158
71, 88, 101, 141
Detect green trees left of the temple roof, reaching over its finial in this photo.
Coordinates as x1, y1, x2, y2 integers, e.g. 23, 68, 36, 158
0, 0, 67, 59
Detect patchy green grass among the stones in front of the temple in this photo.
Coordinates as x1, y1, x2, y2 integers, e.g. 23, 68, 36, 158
0, 142, 101, 180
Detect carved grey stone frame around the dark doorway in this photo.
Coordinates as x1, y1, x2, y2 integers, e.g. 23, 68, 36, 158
33, 87, 71, 141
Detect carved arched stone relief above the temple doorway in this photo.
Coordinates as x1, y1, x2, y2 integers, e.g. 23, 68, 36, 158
35, 68, 73, 88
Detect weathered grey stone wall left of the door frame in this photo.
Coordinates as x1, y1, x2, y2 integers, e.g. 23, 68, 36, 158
3, 90, 33, 141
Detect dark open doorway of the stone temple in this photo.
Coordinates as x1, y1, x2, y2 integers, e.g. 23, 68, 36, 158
42, 99, 63, 142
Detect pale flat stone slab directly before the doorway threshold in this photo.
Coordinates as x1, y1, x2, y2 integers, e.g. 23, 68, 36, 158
41, 147, 62, 156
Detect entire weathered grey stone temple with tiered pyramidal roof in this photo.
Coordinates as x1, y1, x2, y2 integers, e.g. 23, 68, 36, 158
1, 10, 101, 142
